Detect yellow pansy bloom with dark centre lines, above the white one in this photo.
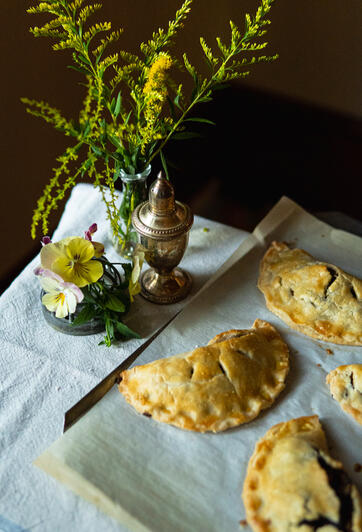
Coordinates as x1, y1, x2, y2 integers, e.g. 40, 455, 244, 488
40, 237, 103, 287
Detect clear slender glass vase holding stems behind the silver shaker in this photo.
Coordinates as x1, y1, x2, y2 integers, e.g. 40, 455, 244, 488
112, 165, 151, 259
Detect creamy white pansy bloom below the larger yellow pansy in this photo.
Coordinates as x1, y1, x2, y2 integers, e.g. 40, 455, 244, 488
34, 268, 84, 318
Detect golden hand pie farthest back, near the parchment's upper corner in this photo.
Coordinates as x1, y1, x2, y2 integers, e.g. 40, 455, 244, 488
258, 242, 362, 345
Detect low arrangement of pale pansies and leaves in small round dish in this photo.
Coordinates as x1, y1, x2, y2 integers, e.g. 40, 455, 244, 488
34, 224, 142, 347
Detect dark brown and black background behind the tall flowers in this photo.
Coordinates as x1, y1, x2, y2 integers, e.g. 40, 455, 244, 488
0, 0, 362, 288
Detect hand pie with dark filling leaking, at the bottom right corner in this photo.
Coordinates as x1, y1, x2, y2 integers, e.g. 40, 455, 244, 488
242, 416, 362, 532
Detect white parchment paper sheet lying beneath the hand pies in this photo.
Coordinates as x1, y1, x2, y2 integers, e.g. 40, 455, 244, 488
37, 197, 362, 532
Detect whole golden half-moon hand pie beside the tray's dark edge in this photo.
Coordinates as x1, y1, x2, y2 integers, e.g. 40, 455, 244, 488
119, 320, 289, 432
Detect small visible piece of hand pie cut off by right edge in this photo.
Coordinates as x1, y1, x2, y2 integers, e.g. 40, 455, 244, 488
326, 364, 362, 425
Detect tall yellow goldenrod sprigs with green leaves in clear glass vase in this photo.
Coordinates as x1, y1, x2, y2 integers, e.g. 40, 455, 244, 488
22, 0, 277, 254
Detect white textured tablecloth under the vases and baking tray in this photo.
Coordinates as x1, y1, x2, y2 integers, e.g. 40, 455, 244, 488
0, 184, 247, 532
